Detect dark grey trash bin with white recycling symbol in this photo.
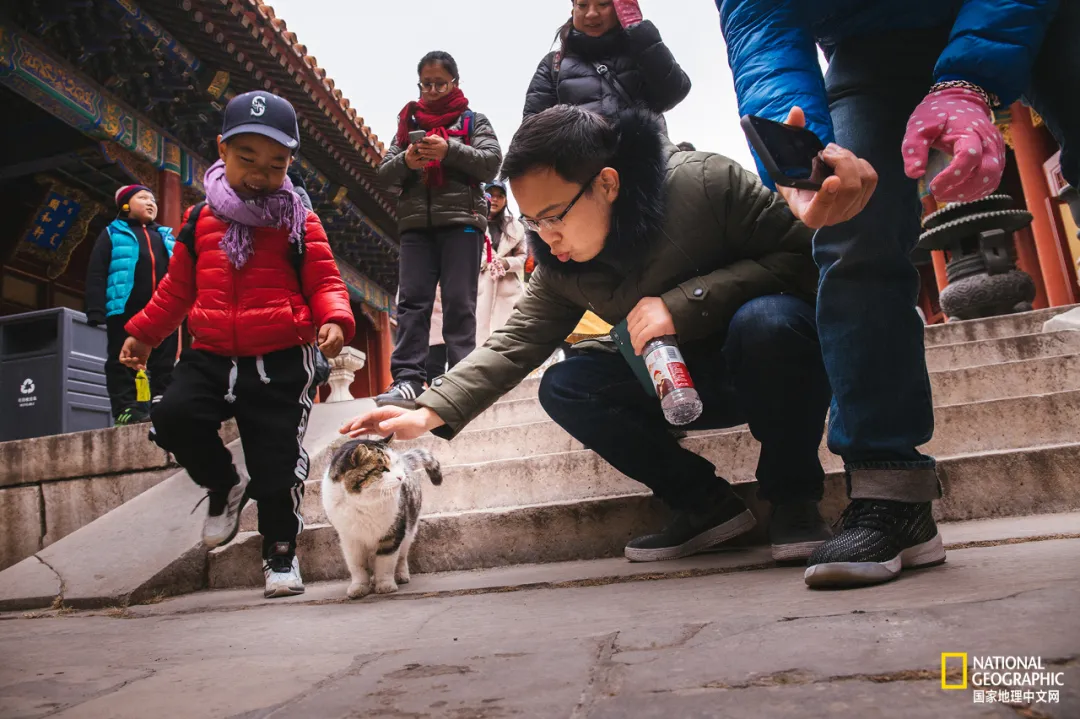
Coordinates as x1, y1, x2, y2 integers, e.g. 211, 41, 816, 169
0, 308, 112, 442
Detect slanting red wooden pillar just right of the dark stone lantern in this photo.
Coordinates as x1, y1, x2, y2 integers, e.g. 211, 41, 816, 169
1009, 103, 1076, 307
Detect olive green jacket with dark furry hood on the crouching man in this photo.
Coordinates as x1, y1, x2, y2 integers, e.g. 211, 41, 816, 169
417, 111, 818, 438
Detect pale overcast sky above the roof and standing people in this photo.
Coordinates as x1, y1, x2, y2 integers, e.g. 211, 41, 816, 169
269, 0, 754, 208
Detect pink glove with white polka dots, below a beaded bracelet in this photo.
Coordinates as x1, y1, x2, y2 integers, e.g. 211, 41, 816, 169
902, 87, 1005, 202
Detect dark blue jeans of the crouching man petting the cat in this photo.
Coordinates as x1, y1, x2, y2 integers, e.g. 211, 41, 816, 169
540, 295, 829, 510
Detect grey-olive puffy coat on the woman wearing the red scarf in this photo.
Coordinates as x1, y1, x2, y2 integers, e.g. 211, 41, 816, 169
379, 112, 502, 232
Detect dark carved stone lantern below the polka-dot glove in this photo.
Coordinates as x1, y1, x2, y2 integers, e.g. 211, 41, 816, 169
918, 194, 1035, 321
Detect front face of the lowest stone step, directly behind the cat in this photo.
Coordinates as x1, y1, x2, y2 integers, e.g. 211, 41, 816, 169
207, 444, 1080, 588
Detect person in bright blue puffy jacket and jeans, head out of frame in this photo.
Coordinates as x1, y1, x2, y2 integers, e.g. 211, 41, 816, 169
716, 0, 1067, 587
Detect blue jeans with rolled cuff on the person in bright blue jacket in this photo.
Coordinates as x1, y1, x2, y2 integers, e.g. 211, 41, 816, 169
814, 16, 1080, 502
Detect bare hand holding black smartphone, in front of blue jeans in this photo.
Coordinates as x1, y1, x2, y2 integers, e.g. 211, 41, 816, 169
743, 107, 878, 229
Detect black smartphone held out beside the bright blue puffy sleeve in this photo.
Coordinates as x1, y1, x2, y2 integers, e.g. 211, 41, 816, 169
741, 114, 833, 191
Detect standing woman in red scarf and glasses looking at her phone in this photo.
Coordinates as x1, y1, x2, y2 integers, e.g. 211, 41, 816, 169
376, 52, 502, 409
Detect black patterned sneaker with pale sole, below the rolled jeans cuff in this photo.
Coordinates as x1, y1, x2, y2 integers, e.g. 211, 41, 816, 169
805, 500, 945, 587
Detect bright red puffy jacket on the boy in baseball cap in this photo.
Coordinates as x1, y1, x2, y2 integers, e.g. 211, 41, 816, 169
126, 205, 356, 357
